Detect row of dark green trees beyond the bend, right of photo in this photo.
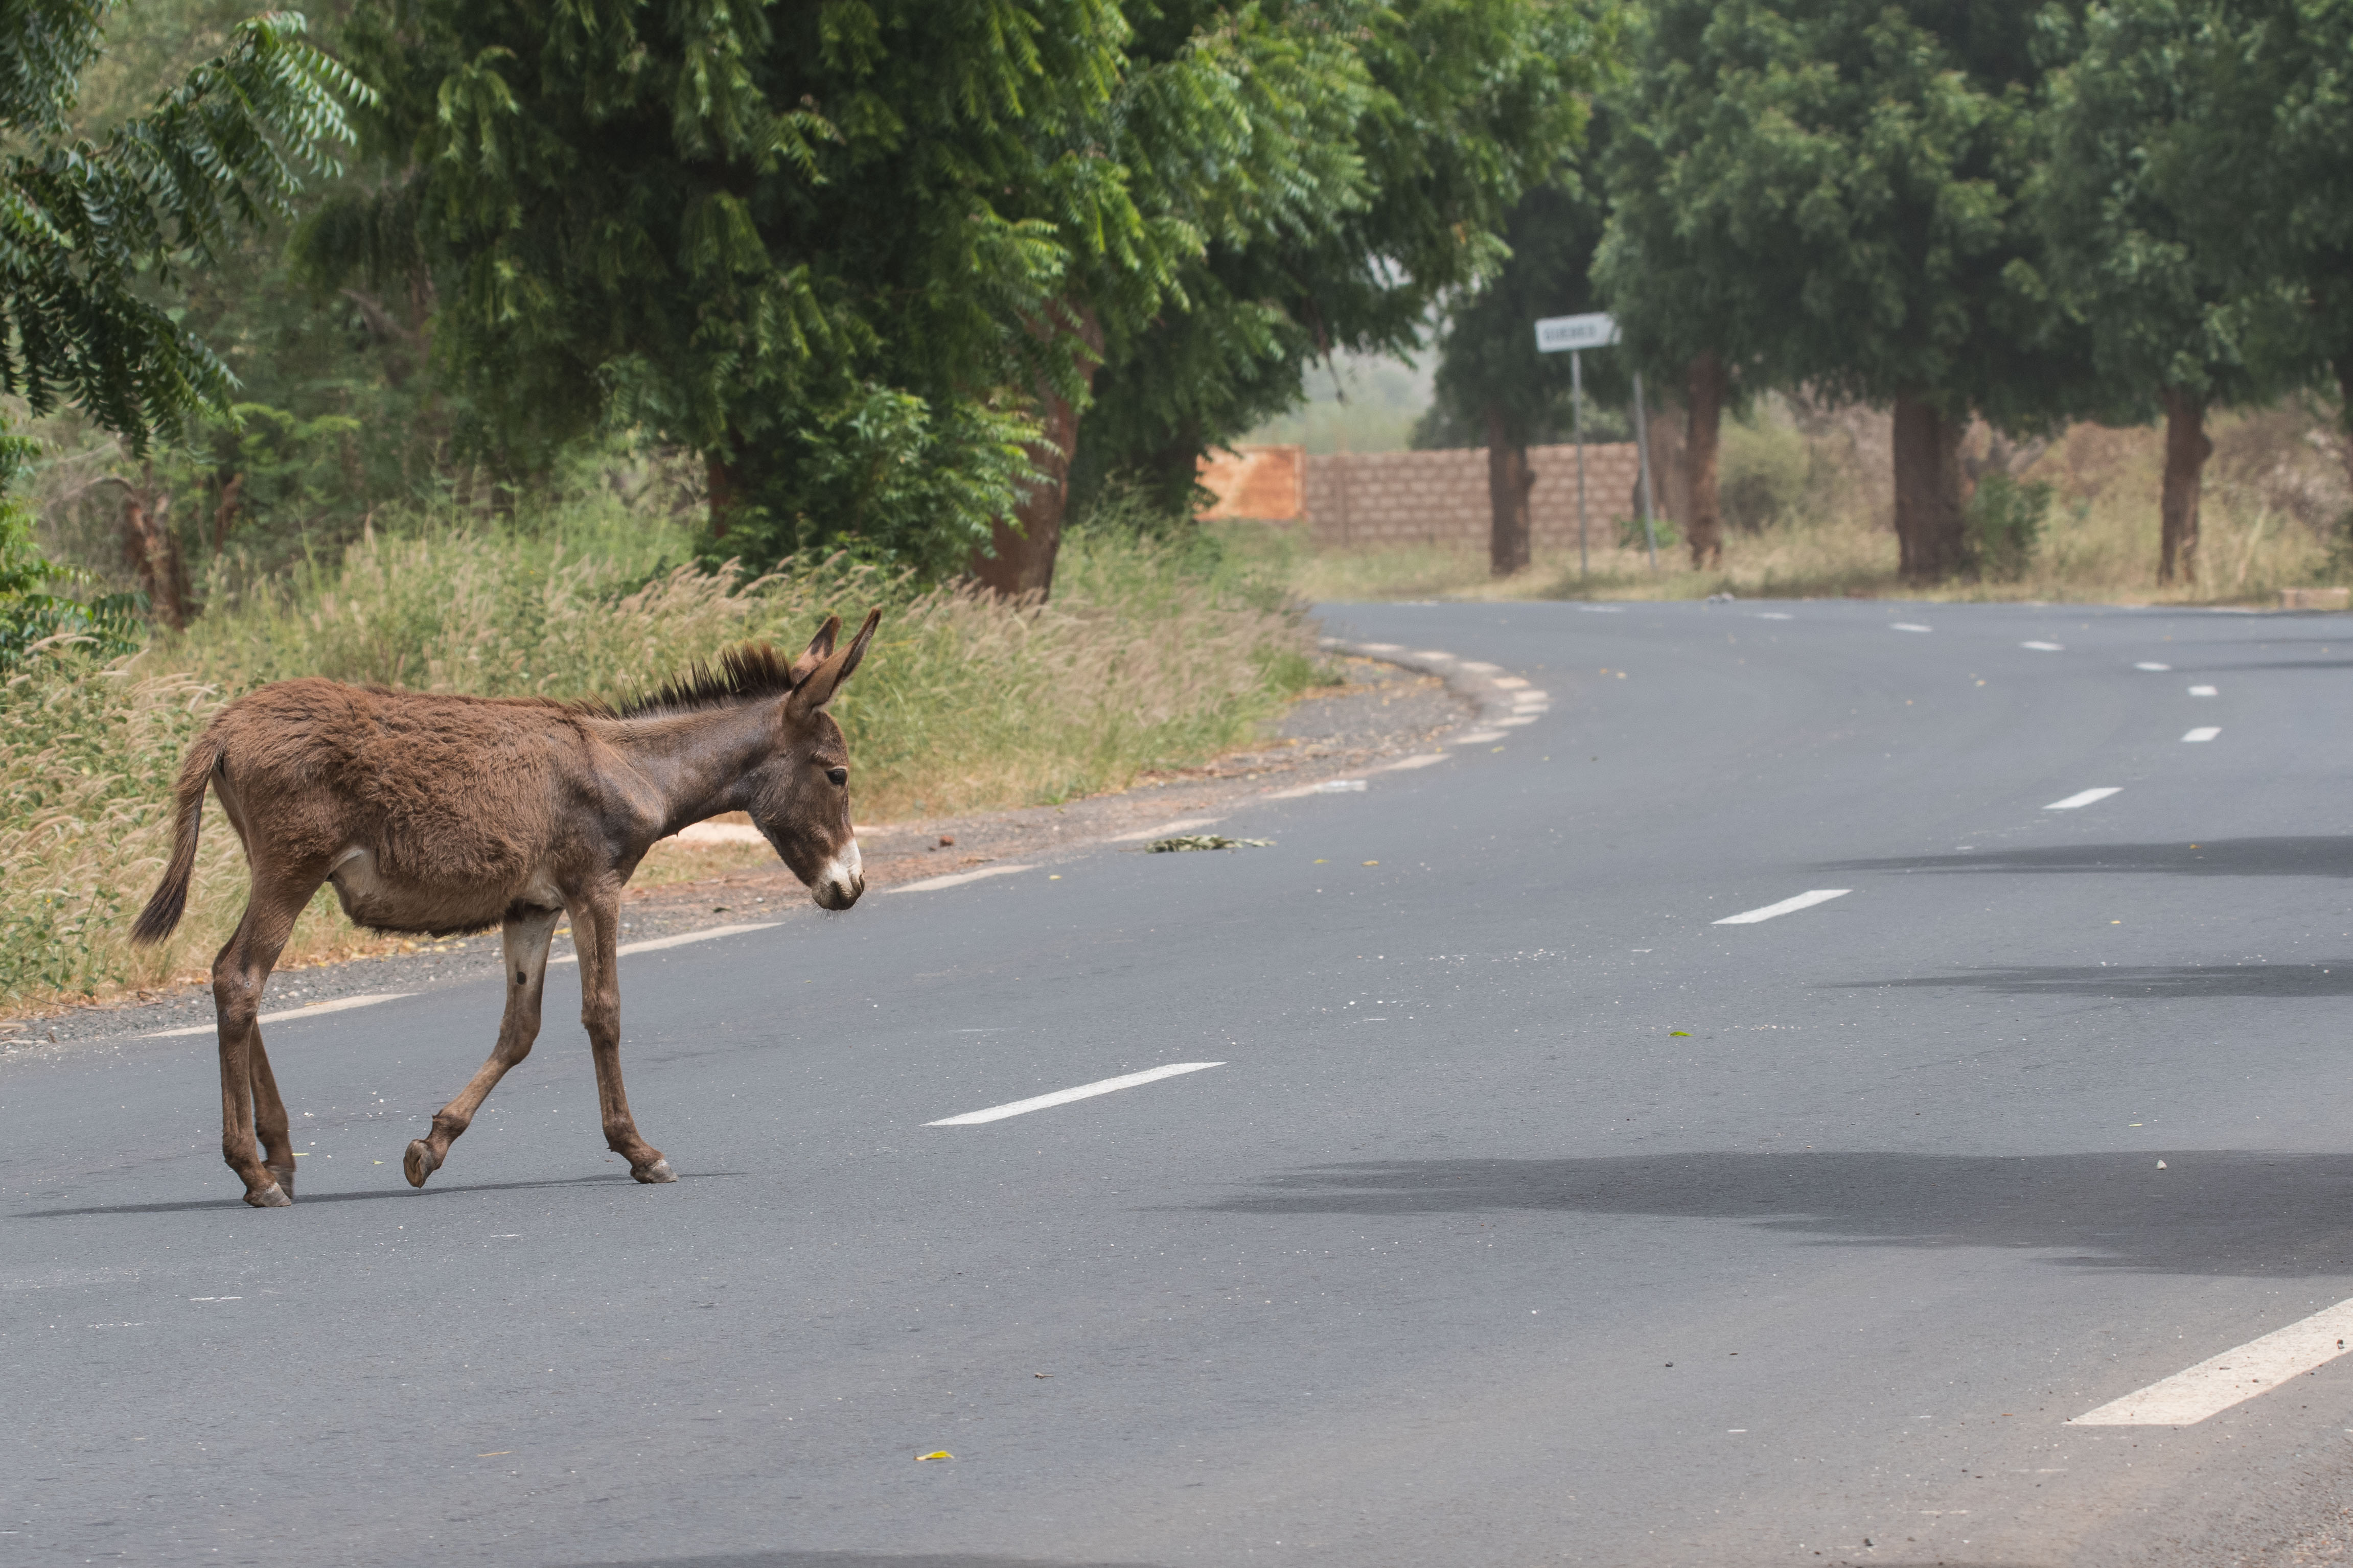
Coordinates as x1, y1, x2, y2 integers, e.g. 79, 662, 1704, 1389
1438, 0, 2353, 583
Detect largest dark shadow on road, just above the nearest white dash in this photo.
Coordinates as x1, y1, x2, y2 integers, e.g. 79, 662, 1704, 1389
1200, 1138, 2353, 1276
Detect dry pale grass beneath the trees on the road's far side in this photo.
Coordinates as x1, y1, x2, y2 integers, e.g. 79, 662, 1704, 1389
1226, 407, 2353, 604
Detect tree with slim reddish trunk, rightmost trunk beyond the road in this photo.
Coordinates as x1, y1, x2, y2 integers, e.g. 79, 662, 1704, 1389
2033, 0, 2294, 583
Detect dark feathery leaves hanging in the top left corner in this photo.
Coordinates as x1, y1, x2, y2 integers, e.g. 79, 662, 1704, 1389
0, 0, 365, 449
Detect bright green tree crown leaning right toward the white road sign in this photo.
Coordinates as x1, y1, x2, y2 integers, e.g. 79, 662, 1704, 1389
1080, 0, 1619, 541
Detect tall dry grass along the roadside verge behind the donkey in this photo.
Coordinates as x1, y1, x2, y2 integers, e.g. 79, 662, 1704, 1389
0, 514, 1316, 1001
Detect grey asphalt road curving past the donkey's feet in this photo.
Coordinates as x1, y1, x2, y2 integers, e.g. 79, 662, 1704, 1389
14, 602, 2353, 1568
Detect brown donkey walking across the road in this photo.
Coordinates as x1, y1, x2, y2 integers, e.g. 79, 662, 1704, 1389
132, 609, 883, 1208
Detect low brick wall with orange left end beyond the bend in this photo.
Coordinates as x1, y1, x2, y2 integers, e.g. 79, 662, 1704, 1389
1203, 442, 1637, 550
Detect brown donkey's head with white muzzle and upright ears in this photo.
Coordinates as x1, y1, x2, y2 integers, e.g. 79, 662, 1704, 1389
748, 609, 883, 910
